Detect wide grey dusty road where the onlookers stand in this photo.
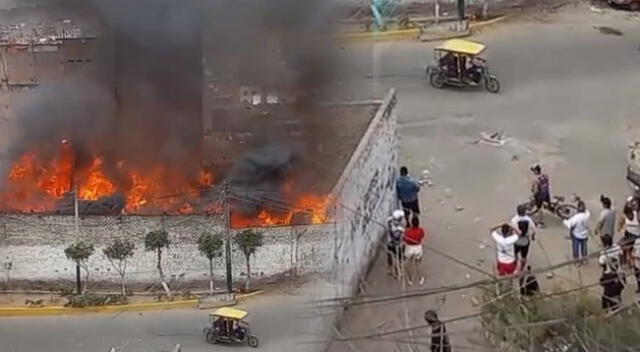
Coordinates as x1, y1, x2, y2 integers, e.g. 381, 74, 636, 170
332, 6, 640, 352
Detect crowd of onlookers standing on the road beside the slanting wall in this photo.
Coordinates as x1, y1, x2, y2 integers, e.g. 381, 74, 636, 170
386, 165, 640, 343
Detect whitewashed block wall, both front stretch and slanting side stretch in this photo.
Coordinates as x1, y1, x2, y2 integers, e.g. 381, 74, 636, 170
0, 90, 397, 298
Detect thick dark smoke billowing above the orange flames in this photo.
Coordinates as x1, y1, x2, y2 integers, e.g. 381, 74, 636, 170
0, 0, 337, 214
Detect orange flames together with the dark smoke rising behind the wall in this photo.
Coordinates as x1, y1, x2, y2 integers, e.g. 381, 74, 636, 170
0, 0, 339, 226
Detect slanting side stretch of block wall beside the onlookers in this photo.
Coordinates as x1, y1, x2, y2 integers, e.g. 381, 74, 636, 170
332, 89, 398, 296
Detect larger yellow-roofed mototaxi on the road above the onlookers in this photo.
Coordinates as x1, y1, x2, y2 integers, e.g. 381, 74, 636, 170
426, 39, 500, 93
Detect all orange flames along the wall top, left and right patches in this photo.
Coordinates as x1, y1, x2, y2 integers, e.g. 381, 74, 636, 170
0, 143, 329, 228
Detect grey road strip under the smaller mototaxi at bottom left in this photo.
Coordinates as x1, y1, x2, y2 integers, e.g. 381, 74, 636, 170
0, 284, 317, 352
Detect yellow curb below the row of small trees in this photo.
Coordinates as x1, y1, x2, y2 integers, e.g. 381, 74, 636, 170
0, 290, 263, 317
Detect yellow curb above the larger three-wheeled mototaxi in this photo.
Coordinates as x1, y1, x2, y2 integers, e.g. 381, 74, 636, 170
331, 16, 507, 43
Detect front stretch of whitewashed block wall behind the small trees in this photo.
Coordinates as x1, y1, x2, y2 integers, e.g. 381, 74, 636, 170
0, 215, 333, 282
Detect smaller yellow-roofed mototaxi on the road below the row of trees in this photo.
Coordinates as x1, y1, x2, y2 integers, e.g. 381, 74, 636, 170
203, 307, 258, 348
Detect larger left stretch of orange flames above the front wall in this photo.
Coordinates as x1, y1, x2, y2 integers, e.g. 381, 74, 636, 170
0, 143, 214, 214
